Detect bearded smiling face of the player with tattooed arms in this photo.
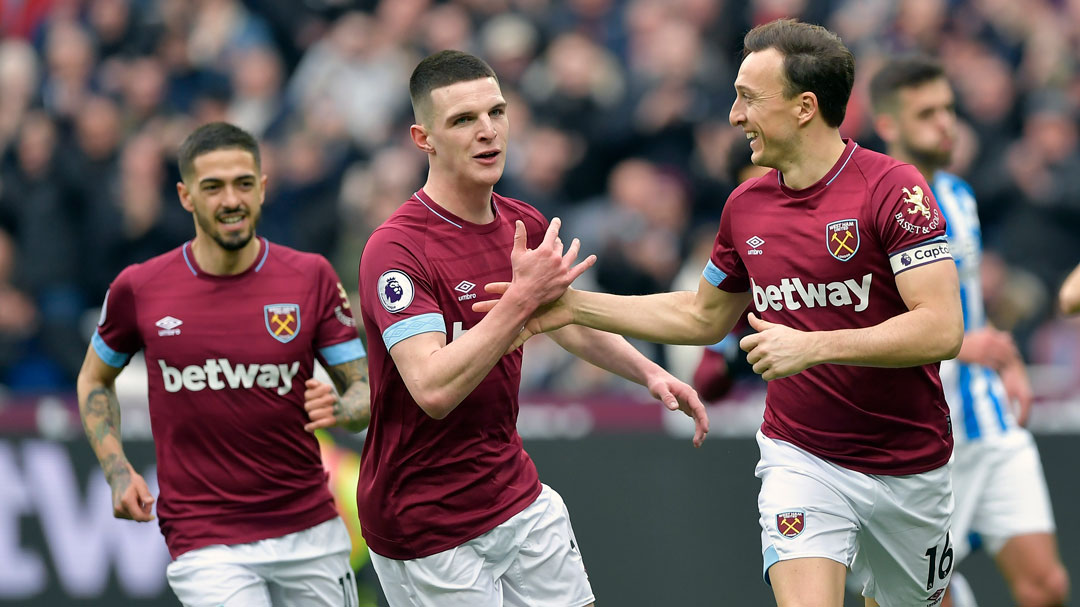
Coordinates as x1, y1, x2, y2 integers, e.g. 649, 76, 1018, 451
177, 148, 267, 252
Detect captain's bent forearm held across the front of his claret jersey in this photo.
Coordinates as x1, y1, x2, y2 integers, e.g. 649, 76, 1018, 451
813, 308, 963, 367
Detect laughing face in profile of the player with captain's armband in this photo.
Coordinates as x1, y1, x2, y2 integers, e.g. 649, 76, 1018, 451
728, 49, 800, 170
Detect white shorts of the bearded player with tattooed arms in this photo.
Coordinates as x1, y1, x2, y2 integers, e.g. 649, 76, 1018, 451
165, 516, 359, 607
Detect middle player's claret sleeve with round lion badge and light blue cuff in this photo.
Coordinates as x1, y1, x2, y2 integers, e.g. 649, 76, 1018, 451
360, 229, 446, 351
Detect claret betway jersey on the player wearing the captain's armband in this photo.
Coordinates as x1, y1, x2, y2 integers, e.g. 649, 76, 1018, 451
704, 140, 953, 474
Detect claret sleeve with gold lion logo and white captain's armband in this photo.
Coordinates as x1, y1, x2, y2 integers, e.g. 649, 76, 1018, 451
872, 164, 953, 274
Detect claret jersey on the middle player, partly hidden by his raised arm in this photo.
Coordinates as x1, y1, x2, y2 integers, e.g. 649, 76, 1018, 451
357, 190, 548, 559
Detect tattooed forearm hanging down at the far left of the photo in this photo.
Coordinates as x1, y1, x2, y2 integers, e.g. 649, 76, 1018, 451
78, 378, 131, 485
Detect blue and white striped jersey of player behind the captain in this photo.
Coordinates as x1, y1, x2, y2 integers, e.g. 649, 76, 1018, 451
931, 171, 1020, 444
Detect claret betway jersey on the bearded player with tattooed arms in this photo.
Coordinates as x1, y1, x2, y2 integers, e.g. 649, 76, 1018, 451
92, 239, 364, 558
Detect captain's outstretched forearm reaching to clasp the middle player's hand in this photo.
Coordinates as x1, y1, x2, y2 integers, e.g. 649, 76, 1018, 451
570, 291, 725, 346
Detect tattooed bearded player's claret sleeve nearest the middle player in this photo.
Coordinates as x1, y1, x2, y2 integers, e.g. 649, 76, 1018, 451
314, 256, 366, 365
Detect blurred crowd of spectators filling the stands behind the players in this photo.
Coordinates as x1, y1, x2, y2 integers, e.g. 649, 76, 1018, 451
0, 0, 1080, 391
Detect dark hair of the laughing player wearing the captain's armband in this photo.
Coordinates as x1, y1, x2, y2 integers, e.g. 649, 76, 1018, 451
743, 19, 855, 126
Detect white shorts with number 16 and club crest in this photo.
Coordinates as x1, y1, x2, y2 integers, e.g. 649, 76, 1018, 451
756, 431, 955, 607
